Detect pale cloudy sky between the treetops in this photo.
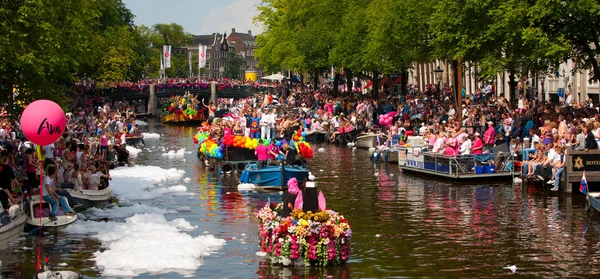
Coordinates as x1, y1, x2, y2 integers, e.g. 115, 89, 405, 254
123, 0, 262, 35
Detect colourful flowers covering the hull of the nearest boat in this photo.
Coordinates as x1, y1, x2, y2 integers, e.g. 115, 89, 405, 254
256, 204, 352, 266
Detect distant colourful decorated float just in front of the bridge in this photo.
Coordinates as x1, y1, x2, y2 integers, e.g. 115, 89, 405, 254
160, 95, 204, 124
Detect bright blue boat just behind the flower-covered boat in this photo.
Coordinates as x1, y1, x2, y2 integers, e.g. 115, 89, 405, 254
240, 164, 310, 189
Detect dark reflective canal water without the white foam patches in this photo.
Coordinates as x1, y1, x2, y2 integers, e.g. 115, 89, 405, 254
0, 123, 600, 278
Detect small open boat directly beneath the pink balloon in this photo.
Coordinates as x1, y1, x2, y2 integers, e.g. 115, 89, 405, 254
27, 195, 77, 228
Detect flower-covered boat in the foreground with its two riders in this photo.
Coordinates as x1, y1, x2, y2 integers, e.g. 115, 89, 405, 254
256, 179, 352, 266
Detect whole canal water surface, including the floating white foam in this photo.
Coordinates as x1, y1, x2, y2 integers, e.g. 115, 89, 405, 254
0, 121, 600, 278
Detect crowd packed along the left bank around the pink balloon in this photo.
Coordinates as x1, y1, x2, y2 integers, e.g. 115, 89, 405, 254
0, 99, 141, 219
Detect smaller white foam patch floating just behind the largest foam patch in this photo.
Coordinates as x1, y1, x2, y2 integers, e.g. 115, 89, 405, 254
110, 166, 187, 200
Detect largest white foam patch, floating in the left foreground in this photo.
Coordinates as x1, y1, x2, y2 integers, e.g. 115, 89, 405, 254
65, 214, 225, 277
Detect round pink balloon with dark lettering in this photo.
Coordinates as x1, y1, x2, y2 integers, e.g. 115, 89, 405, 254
21, 100, 67, 146
